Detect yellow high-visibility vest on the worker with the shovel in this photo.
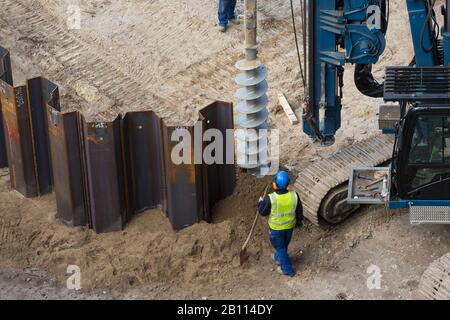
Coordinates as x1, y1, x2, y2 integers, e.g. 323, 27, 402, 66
269, 191, 298, 230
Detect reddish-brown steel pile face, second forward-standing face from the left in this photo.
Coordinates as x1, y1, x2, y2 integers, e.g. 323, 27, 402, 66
47, 106, 88, 226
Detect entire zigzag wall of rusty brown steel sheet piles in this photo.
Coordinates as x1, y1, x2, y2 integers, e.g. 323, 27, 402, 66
0, 47, 235, 233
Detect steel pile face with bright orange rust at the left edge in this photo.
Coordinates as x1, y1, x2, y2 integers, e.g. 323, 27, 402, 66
0, 80, 39, 197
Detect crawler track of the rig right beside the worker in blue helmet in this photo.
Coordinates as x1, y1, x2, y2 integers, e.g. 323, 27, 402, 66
294, 135, 394, 225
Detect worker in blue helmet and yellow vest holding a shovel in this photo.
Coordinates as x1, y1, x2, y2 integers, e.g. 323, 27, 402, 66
258, 171, 303, 277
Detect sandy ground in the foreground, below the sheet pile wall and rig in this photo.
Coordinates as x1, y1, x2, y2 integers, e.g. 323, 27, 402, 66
0, 168, 450, 299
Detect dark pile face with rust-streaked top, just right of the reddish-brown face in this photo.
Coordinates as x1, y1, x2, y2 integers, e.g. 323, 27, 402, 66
83, 116, 127, 233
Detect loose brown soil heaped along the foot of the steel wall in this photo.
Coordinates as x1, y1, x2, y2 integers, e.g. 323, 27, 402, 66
0, 170, 274, 292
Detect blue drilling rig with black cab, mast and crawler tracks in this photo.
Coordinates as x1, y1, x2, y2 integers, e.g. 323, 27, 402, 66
237, 0, 450, 298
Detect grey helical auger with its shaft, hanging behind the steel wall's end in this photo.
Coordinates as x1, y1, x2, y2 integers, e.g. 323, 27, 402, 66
235, 0, 269, 176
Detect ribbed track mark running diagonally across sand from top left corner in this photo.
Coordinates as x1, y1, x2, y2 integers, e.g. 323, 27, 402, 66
0, 0, 186, 123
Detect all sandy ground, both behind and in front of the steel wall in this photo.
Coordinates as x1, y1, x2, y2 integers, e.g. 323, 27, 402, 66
0, 0, 450, 299
